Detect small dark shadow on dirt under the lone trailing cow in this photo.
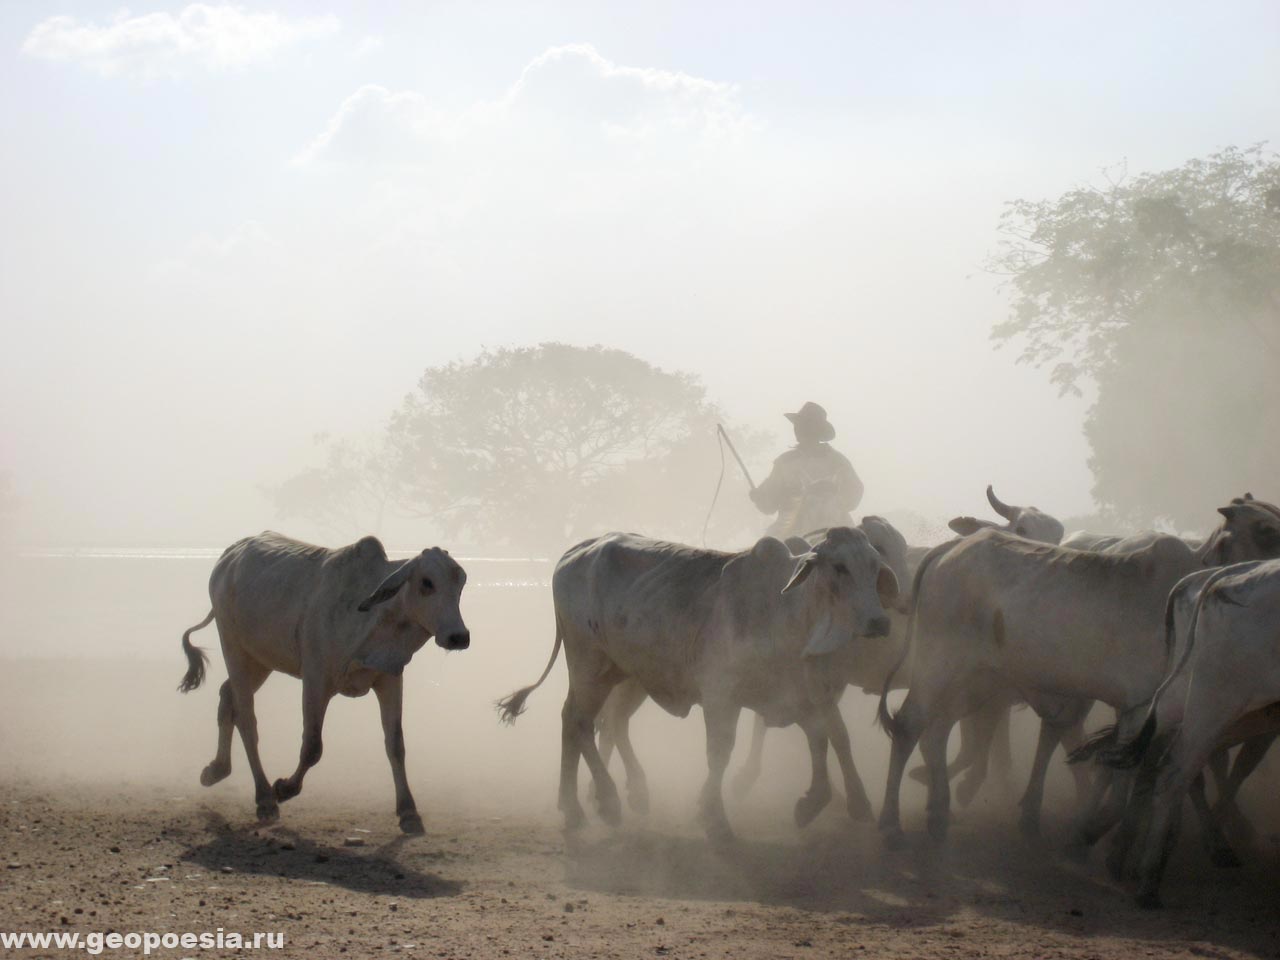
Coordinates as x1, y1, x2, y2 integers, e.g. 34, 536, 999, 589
180, 809, 462, 900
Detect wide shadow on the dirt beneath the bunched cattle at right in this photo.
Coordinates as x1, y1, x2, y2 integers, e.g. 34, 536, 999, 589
566, 820, 1280, 957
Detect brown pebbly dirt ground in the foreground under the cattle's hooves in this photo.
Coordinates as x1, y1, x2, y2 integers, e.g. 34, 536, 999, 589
0, 762, 1280, 957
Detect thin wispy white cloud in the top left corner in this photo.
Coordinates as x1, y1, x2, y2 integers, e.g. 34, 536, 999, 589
22, 4, 338, 78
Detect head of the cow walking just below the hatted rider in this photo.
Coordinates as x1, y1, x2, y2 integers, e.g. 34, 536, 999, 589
782, 526, 899, 657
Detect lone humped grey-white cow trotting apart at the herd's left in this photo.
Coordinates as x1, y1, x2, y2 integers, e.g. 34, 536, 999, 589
178, 531, 471, 833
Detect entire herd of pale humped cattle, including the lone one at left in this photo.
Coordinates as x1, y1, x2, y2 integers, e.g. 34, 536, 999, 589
180, 488, 1280, 906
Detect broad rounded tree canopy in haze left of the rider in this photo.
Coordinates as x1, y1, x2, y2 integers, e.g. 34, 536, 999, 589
274, 343, 759, 554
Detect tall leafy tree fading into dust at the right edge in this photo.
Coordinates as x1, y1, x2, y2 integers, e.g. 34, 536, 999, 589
992, 146, 1280, 527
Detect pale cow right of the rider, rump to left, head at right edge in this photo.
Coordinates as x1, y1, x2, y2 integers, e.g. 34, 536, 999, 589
881, 500, 1280, 851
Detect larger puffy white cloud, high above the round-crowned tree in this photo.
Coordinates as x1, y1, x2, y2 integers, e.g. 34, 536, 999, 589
296, 44, 754, 164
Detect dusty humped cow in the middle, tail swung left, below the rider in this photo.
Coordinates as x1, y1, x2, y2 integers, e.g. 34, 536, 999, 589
498, 527, 899, 840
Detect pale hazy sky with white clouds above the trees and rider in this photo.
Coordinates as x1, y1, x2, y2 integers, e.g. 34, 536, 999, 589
0, 0, 1280, 544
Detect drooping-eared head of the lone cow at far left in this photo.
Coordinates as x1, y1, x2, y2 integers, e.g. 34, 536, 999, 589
357, 547, 471, 673
